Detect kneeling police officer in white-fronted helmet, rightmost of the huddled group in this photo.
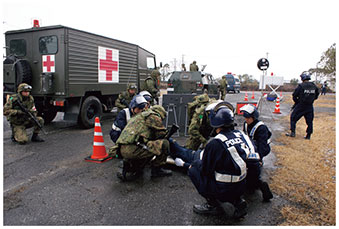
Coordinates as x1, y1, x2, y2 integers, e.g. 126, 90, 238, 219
240, 104, 273, 202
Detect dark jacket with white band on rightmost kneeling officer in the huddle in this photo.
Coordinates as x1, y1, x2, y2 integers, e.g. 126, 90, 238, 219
244, 119, 272, 159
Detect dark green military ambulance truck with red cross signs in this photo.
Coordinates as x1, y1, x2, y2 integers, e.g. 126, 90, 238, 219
3, 25, 156, 128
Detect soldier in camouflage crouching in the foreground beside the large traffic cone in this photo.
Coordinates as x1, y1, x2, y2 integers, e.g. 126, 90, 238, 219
116, 105, 172, 180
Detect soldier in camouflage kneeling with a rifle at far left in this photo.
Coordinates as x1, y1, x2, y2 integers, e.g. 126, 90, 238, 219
4, 83, 44, 144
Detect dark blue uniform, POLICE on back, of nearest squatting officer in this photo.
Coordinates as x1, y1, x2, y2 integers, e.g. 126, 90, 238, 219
188, 130, 255, 201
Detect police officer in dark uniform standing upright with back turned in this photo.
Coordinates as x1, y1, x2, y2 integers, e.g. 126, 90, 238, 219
286, 72, 319, 140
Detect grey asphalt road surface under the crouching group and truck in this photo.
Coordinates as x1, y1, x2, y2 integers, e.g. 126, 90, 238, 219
3, 92, 289, 225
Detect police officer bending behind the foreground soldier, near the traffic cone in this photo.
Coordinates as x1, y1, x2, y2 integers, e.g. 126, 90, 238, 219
109, 95, 148, 143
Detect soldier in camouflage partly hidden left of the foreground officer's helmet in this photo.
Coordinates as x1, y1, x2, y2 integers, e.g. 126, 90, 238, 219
185, 95, 216, 150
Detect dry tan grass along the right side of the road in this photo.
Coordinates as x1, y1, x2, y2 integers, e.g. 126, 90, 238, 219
271, 97, 336, 225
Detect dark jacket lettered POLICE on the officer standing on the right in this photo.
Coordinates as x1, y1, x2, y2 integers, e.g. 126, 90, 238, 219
293, 81, 319, 107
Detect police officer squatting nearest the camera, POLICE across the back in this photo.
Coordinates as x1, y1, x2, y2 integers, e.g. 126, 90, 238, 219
188, 106, 255, 218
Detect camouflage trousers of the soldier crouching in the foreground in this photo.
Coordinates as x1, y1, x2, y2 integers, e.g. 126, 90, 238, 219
120, 139, 169, 167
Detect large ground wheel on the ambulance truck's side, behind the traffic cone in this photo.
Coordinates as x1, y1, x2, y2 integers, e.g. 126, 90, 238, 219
78, 96, 102, 128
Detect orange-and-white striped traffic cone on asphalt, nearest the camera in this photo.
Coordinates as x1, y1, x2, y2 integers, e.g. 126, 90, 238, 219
85, 117, 112, 163
